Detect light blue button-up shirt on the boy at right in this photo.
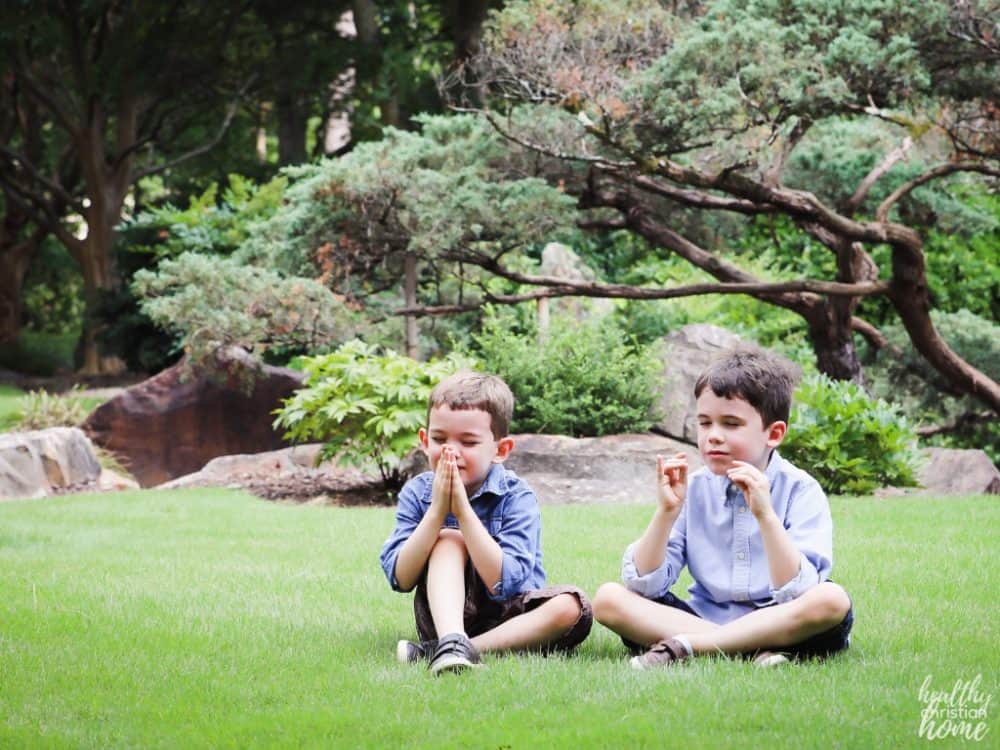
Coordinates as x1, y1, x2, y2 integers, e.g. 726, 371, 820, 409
622, 451, 833, 624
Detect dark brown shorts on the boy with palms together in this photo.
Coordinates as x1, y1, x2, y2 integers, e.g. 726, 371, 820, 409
413, 563, 594, 653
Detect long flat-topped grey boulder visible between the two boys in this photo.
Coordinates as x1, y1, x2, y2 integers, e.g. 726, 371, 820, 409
406, 434, 702, 505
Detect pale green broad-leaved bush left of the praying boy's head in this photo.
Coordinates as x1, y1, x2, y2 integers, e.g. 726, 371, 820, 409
274, 339, 472, 487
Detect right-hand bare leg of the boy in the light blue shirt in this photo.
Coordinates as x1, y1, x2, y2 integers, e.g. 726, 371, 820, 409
680, 581, 851, 654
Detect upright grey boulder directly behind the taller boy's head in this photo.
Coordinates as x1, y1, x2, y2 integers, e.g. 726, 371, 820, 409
655, 323, 741, 443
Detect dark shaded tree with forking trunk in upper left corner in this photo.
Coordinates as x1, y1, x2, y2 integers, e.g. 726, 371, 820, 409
0, 0, 254, 373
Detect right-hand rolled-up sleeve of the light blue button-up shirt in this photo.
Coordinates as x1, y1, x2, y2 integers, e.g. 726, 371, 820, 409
771, 480, 833, 604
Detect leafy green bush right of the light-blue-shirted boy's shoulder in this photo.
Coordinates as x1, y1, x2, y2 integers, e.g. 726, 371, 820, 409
781, 375, 920, 494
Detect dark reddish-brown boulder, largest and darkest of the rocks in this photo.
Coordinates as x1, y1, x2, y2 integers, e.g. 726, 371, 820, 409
83, 349, 303, 487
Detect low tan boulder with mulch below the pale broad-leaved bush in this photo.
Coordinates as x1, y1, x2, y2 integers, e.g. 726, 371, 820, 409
157, 443, 395, 505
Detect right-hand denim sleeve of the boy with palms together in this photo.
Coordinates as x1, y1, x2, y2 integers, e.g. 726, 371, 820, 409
487, 487, 542, 601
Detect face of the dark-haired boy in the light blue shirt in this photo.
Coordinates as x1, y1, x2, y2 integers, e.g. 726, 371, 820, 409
697, 388, 788, 474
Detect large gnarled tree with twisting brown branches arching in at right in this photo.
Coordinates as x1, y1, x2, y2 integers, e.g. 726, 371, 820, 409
448, 0, 1000, 410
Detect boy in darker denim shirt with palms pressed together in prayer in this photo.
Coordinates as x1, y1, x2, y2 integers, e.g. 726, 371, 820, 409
380, 372, 592, 675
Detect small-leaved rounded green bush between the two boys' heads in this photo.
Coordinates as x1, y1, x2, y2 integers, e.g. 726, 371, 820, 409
473, 315, 662, 436
